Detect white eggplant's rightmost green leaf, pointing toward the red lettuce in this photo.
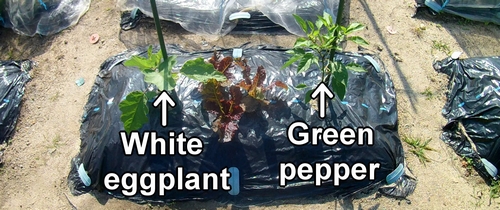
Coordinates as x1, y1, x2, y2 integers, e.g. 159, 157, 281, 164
180, 58, 227, 83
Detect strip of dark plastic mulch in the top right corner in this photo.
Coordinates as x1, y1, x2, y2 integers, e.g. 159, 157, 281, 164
417, 0, 500, 24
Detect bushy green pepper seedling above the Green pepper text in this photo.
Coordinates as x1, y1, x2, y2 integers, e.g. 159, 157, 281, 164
282, 12, 368, 103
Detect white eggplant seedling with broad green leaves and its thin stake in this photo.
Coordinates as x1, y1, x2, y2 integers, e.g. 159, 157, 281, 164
119, 0, 226, 133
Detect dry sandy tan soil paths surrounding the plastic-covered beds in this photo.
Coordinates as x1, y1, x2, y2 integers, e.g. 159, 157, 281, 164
0, 0, 500, 209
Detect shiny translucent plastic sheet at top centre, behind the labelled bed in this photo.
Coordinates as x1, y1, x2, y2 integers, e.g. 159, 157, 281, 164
118, 0, 339, 35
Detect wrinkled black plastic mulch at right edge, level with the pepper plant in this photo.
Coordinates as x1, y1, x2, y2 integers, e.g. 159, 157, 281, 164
434, 57, 500, 179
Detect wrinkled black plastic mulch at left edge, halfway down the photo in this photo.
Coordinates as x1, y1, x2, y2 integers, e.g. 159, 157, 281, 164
0, 60, 33, 144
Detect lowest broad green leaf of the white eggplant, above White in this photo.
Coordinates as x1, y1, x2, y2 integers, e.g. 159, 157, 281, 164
119, 91, 149, 133
